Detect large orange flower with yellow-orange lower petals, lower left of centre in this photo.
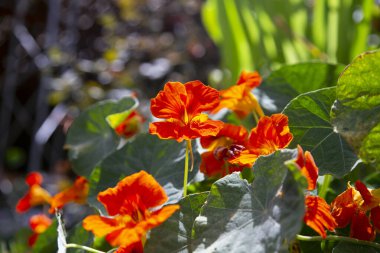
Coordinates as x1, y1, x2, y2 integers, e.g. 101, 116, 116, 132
83, 171, 179, 252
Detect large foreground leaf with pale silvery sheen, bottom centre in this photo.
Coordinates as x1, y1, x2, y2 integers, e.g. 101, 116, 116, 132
193, 150, 305, 252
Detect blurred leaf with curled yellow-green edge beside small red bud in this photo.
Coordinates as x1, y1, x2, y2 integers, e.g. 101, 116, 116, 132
66, 98, 136, 177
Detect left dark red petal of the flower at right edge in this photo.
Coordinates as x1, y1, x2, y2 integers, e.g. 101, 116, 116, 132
331, 187, 357, 228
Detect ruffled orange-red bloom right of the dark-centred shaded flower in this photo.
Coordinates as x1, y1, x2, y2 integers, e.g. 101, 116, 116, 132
230, 114, 293, 167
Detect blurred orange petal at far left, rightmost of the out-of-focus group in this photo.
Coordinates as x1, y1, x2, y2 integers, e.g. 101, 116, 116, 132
49, 177, 89, 213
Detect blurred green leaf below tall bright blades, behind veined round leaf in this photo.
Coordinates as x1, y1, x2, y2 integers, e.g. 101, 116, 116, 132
258, 62, 343, 113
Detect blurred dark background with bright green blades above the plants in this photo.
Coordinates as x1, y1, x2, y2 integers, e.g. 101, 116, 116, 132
0, 0, 380, 246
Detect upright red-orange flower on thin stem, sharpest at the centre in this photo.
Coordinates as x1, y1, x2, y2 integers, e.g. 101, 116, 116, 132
149, 81, 223, 142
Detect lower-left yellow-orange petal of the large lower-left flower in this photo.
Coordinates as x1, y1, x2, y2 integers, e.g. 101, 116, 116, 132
82, 215, 124, 240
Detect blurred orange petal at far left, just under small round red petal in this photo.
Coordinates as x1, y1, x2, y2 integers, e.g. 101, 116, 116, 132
16, 184, 51, 213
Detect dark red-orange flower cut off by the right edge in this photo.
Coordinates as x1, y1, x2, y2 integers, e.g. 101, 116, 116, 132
331, 180, 380, 241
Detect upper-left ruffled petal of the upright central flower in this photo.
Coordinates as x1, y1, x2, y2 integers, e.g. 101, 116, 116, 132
150, 82, 187, 119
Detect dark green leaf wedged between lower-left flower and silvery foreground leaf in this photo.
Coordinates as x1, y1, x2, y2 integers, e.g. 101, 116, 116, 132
144, 192, 208, 253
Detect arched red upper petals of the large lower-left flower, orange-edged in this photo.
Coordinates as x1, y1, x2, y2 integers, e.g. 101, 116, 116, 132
98, 170, 168, 215
